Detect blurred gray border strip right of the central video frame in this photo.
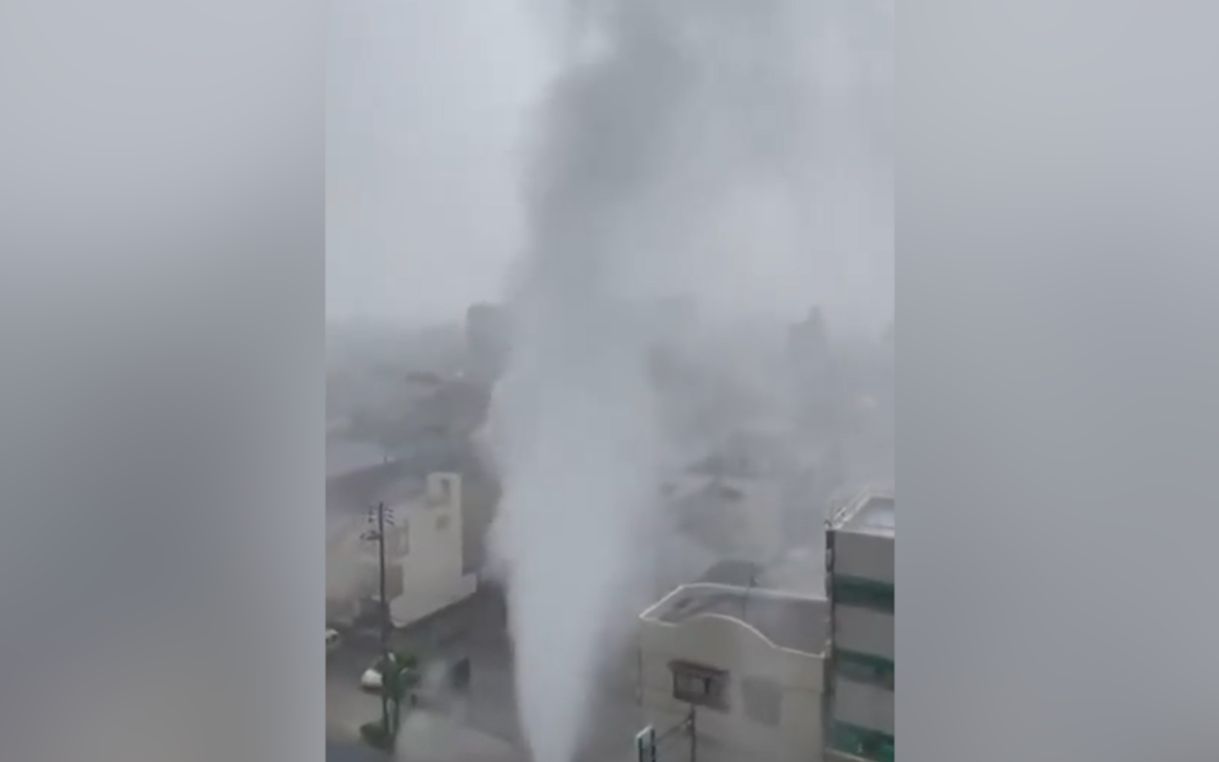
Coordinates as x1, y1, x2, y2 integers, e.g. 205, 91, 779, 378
896, 0, 1219, 762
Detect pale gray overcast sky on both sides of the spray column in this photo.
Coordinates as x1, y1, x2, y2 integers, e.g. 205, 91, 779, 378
325, 0, 894, 333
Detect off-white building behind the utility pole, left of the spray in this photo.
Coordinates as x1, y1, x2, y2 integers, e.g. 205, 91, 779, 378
327, 473, 478, 627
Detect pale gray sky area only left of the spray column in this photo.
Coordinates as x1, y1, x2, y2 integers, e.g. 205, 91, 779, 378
325, 0, 550, 322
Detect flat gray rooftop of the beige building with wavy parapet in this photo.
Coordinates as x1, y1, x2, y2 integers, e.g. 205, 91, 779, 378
641, 582, 829, 653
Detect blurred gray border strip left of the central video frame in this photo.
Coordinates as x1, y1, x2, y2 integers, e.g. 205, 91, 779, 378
0, 0, 328, 762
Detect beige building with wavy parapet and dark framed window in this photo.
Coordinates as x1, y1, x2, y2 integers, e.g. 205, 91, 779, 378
639, 562, 829, 762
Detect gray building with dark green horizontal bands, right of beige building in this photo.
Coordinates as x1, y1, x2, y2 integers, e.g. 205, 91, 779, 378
825, 490, 896, 762
